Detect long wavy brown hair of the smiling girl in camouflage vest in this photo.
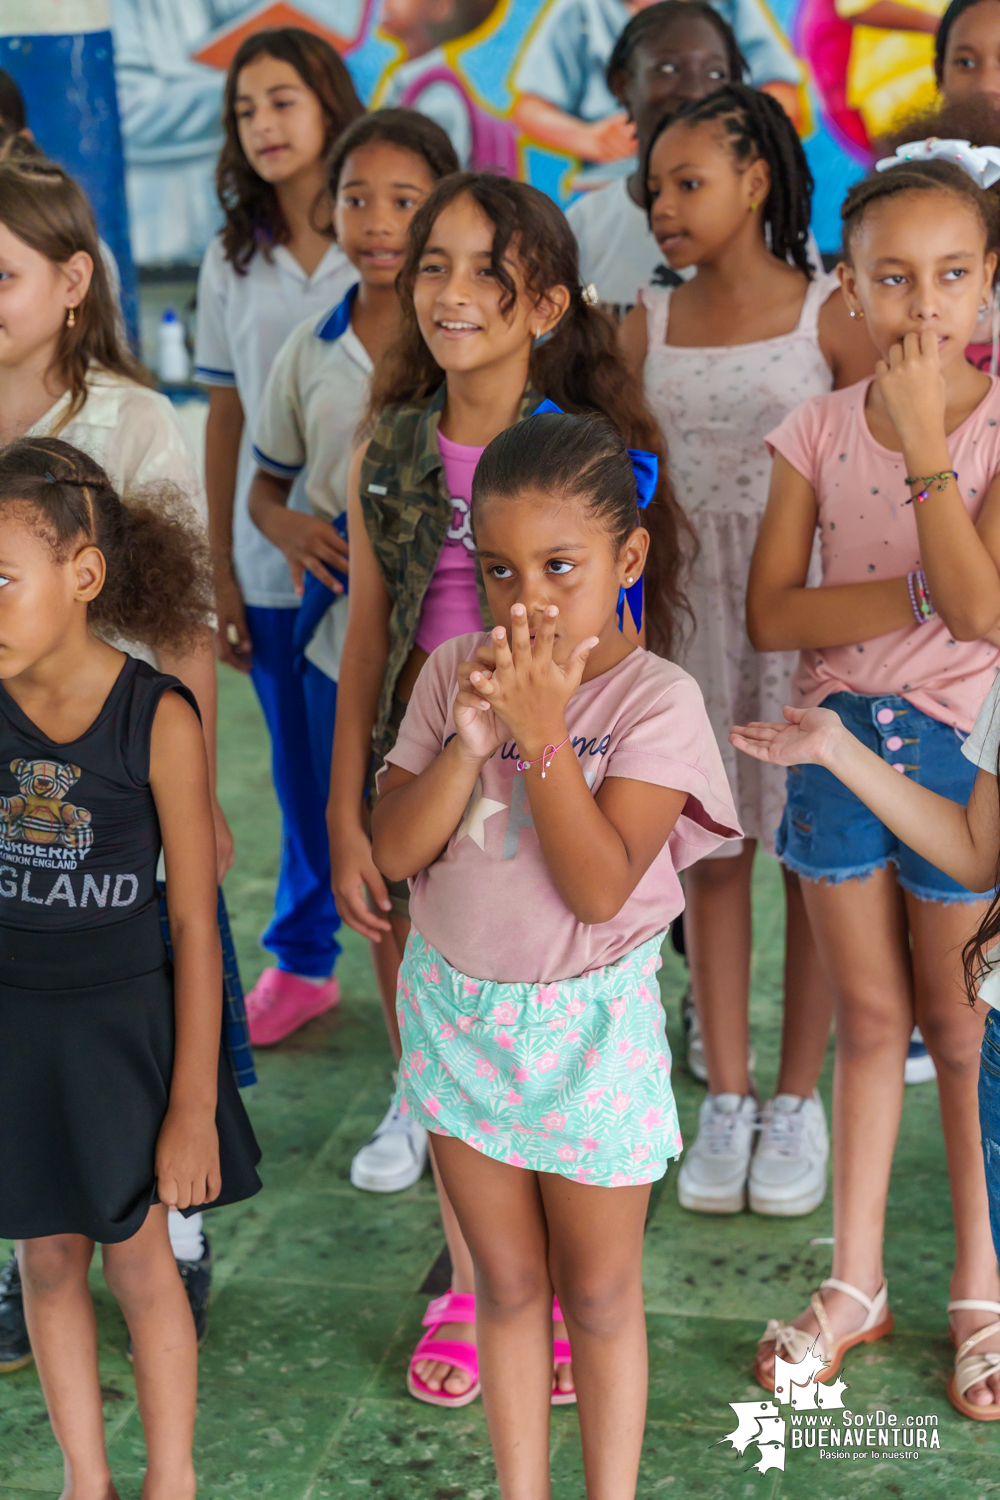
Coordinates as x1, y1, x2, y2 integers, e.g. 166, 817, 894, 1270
364, 173, 694, 656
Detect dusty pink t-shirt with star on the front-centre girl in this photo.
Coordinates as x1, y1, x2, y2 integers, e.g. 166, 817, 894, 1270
379, 630, 741, 984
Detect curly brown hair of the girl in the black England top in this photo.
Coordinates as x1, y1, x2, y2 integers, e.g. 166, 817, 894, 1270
0, 438, 213, 654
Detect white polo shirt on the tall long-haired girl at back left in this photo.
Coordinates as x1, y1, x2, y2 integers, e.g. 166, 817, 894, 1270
195, 239, 357, 609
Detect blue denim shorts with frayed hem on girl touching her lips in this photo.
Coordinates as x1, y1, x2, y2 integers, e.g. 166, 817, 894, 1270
775, 693, 993, 905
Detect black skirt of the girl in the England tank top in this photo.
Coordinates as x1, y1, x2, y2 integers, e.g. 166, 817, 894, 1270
0, 906, 261, 1245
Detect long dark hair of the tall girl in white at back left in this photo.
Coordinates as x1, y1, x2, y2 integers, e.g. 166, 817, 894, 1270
216, 26, 364, 275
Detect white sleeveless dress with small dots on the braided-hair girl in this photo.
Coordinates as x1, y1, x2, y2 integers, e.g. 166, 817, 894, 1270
639, 272, 840, 854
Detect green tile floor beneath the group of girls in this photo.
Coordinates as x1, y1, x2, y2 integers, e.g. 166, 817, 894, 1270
0, 672, 1000, 1500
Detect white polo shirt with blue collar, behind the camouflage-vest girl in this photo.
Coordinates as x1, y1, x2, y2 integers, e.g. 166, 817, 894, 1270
253, 285, 373, 681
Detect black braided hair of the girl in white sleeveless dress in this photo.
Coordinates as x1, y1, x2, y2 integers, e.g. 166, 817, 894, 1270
643, 84, 813, 281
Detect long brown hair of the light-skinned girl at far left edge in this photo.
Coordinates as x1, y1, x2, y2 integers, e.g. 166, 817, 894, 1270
0, 156, 153, 426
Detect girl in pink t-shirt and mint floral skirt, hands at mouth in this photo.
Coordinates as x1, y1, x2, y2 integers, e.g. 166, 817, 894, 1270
372, 414, 739, 1497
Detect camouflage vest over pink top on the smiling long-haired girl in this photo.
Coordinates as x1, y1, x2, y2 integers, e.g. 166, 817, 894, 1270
360, 384, 541, 762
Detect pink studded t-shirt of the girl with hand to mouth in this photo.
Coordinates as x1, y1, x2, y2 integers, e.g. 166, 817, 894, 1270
766, 380, 1000, 734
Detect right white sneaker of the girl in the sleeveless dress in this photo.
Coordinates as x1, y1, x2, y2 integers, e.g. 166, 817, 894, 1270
750, 1092, 831, 1215
